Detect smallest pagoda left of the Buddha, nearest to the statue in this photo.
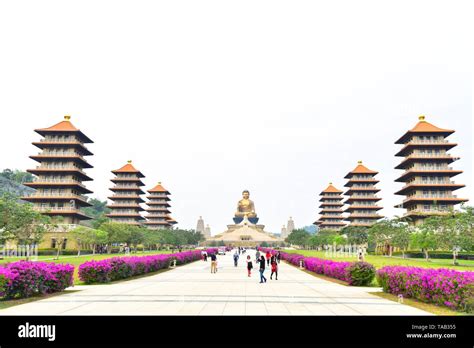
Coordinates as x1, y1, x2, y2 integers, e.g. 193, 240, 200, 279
144, 182, 177, 229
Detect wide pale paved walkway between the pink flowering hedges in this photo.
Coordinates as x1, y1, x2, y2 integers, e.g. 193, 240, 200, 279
0, 251, 430, 315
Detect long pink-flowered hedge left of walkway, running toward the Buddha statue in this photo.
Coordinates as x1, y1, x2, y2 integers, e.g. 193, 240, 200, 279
79, 248, 212, 284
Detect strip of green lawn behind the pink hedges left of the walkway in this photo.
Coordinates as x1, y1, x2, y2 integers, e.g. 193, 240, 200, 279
0, 249, 186, 285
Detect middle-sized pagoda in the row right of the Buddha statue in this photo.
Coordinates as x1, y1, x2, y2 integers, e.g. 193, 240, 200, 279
344, 161, 383, 227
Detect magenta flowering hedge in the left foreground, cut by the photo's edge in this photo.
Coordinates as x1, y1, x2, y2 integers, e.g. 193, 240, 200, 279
0, 261, 74, 299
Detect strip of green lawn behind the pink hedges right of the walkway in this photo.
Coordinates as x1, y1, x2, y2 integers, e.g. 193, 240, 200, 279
284, 249, 474, 271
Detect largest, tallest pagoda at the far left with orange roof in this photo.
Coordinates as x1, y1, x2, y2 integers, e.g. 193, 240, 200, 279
22, 116, 92, 224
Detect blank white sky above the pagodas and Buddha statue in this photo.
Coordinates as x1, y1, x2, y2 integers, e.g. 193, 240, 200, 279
0, 0, 474, 234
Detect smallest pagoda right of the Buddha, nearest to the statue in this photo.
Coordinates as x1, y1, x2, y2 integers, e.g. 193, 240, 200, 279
313, 183, 346, 230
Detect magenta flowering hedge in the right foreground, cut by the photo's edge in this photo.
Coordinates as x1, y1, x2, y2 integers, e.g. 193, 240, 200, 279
376, 266, 474, 310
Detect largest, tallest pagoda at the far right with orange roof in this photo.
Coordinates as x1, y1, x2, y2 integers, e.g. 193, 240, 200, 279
395, 116, 467, 225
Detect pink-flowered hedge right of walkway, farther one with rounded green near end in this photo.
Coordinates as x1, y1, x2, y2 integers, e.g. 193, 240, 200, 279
259, 248, 375, 286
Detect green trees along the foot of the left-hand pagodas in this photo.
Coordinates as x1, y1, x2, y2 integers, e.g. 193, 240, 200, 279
0, 193, 204, 257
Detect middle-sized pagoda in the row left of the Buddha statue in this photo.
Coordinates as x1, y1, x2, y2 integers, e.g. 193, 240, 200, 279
106, 161, 145, 226
